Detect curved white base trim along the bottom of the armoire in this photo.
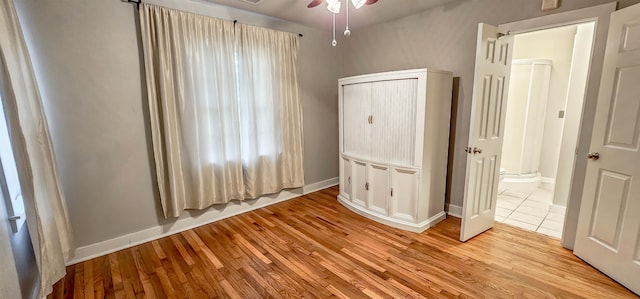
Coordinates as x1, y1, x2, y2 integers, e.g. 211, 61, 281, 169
338, 195, 447, 233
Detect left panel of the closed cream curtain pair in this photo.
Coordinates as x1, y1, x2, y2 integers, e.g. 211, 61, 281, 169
140, 4, 244, 217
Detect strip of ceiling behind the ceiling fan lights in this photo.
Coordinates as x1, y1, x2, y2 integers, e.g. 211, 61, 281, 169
201, 0, 461, 29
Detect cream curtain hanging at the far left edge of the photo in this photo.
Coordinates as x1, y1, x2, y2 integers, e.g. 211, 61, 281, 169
0, 0, 74, 298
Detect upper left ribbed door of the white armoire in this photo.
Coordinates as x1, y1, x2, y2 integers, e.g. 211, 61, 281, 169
342, 83, 371, 159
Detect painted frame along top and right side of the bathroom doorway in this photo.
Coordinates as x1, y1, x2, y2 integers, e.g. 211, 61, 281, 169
498, 2, 617, 249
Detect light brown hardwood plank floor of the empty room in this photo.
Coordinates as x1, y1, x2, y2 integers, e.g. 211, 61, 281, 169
50, 187, 635, 298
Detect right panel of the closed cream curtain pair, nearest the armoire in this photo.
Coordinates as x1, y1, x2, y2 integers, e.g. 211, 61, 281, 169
236, 24, 304, 198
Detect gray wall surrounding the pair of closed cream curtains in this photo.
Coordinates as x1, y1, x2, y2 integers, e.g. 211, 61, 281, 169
16, 0, 339, 246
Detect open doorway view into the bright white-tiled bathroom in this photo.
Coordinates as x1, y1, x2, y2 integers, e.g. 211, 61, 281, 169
495, 22, 595, 239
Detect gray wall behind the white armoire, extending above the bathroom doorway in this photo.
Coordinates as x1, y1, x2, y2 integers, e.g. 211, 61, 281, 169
340, 0, 640, 210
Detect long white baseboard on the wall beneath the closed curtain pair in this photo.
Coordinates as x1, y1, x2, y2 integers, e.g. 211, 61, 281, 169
66, 177, 339, 266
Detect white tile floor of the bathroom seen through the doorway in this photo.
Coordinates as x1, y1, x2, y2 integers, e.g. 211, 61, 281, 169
495, 184, 565, 239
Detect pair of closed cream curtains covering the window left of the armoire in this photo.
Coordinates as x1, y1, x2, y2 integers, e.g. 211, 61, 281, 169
140, 4, 303, 217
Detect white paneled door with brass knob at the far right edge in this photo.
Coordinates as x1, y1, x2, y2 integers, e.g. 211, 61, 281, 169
574, 4, 640, 295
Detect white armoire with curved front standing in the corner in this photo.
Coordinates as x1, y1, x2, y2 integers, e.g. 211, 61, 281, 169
338, 69, 452, 232
